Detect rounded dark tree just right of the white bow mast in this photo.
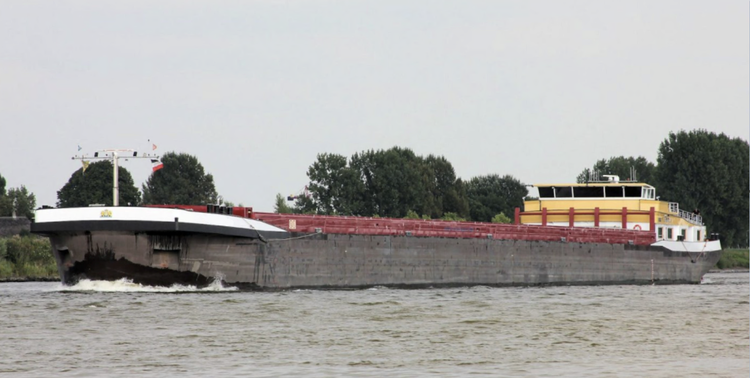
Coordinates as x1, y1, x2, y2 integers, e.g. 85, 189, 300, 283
143, 152, 219, 205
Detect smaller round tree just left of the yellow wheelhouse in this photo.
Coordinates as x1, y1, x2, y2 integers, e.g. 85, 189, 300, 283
466, 174, 529, 222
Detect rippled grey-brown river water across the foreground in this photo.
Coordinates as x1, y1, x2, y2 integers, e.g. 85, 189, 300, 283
0, 273, 750, 378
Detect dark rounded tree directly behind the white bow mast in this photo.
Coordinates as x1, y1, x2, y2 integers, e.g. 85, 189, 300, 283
57, 160, 141, 207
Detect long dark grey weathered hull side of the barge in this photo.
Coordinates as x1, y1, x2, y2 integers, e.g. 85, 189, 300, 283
42, 230, 721, 290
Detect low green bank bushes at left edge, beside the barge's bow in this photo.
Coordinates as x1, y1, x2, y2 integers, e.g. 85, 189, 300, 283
0, 235, 57, 278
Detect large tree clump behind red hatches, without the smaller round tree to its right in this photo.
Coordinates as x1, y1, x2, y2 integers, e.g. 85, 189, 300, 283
302, 147, 468, 218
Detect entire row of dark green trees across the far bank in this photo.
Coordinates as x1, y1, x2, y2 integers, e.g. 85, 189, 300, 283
0, 130, 750, 247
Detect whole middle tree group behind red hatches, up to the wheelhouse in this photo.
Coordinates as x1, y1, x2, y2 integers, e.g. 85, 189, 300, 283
276, 147, 528, 222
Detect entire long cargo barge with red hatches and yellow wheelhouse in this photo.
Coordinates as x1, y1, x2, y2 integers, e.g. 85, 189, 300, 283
31, 178, 721, 290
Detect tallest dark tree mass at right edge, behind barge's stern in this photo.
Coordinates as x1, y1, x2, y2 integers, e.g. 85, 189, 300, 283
656, 130, 750, 247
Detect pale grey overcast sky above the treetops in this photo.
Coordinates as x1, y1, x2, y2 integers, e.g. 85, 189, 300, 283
0, 0, 750, 211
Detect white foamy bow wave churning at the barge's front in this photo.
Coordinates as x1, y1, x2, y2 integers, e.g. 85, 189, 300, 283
57, 278, 237, 293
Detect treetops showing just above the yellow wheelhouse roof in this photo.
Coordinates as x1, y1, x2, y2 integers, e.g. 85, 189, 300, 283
576, 156, 656, 184
